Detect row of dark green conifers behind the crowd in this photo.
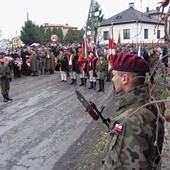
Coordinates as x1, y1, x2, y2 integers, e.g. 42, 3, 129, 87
21, 20, 84, 45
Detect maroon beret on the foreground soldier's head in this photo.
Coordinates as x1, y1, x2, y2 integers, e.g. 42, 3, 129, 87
112, 52, 149, 72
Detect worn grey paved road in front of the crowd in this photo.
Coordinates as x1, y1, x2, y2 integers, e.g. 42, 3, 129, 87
0, 72, 112, 170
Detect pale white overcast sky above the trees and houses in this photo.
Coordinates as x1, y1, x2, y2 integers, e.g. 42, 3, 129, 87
0, 0, 162, 39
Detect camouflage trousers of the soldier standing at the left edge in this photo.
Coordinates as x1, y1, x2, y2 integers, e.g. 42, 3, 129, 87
0, 78, 10, 96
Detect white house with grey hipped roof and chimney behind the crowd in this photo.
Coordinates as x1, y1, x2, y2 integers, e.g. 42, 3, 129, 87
98, 3, 165, 47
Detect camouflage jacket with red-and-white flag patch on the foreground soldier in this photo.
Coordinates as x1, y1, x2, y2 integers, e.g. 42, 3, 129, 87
102, 86, 164, 170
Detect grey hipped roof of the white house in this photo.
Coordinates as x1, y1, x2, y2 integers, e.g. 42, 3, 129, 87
101, 7, 164, 26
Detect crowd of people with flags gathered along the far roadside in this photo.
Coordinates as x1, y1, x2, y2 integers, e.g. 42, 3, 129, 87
0, 44, 167, 101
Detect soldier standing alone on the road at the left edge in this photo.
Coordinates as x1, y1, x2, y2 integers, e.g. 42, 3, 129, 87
0, 56, 12, 102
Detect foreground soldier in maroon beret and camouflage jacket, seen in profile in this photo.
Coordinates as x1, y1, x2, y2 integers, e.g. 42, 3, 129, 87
102, 52, 165, 170
